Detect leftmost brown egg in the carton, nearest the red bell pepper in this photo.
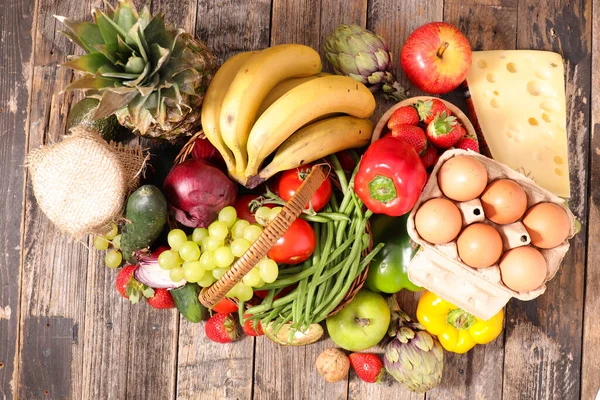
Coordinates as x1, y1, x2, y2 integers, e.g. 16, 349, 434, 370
415, 198, 462, 244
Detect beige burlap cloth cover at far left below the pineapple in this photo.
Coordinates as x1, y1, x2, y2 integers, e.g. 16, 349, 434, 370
27, 127, 144, 239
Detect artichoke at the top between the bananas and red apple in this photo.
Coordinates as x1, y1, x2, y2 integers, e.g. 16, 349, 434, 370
323, 25, 406, 101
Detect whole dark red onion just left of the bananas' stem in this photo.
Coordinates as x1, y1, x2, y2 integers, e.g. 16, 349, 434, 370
163, 160, 237, 228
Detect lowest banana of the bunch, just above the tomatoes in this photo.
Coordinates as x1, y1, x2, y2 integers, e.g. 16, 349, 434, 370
248, 115, 373, 188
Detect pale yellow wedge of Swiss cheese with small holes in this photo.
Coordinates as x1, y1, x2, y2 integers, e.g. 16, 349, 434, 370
467, 50, 570, 197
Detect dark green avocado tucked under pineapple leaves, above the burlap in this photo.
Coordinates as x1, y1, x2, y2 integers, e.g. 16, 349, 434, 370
67, 97, 126, 142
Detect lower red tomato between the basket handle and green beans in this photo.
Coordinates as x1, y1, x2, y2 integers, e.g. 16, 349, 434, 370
267, 218, 317, 264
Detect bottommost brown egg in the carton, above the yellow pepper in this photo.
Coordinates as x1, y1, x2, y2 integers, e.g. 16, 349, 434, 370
500, 246, 548, 292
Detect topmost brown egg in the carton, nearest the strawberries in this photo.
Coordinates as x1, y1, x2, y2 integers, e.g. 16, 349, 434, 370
438, 156, 488, 201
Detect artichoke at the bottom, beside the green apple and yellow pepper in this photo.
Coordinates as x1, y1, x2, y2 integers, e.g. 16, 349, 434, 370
383, 296, 444, 393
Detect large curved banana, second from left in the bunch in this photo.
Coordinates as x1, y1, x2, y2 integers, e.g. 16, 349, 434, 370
220, 44, 322, 172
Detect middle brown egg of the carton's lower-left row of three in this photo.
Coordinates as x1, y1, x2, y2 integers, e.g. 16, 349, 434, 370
456, 223, 502, 268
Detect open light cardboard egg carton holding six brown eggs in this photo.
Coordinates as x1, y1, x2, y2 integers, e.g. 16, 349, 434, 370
407, 150, 576, 320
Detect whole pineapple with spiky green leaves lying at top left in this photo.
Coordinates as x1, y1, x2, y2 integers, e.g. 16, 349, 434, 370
56, 0, 218, 139
